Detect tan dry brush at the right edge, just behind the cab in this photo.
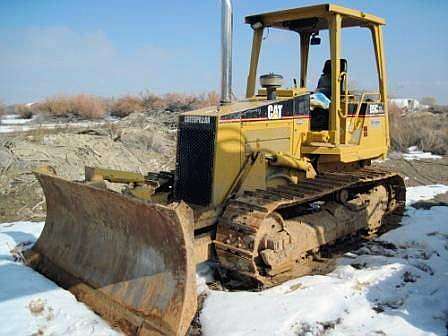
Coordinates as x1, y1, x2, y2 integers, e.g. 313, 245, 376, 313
389, 106, 448, 155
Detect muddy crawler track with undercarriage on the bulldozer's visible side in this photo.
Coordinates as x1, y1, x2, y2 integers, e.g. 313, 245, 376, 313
215, 167, 406, 287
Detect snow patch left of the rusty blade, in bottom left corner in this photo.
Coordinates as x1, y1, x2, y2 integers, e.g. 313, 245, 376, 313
0, 222, 118, 336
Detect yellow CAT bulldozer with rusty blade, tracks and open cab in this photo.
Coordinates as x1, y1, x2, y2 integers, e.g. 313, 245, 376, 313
26, 0, 406, 335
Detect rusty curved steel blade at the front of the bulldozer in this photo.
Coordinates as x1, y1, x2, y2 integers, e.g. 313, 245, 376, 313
27, 173, 197, 335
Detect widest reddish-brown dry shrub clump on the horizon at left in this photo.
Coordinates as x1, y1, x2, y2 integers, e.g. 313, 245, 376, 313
36, 94, 106, 119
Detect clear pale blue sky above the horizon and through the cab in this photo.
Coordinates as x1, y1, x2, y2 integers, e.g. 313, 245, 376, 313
0, 0, 448, 104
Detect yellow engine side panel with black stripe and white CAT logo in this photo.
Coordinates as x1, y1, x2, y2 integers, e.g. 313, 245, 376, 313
213, 94, 309, 205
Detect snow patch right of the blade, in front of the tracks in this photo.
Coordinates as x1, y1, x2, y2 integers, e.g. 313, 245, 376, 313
200, 185, 448, 336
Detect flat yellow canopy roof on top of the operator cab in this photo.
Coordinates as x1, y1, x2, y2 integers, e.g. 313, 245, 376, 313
245, 4, 386, 32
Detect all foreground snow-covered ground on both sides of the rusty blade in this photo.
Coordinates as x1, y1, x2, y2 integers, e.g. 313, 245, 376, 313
0, 185, 448, 336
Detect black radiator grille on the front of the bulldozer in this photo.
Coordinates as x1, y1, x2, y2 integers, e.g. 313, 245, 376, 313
174, 116, 216, 206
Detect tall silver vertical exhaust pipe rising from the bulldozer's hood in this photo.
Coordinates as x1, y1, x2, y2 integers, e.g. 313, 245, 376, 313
221, 0, 233, 105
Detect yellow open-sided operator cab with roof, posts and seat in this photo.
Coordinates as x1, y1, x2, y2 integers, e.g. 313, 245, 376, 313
246, 4, 389, 146
